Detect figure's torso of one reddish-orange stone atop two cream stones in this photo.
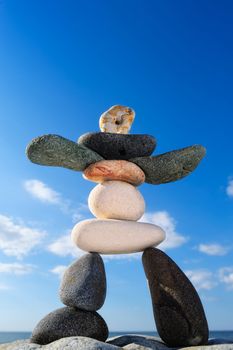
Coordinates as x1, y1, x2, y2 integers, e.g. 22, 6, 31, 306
72, 160, 165, 254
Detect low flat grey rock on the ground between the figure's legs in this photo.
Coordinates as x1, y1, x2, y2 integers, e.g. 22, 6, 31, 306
107, 334, 167, 350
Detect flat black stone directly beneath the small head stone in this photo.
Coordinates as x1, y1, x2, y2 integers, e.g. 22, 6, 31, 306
78, 132, 156, 160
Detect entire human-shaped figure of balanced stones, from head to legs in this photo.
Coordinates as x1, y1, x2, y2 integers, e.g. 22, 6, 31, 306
26, 106, 209, 347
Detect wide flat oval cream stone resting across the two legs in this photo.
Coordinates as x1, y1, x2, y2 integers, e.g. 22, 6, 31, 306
71, 219, 165, 254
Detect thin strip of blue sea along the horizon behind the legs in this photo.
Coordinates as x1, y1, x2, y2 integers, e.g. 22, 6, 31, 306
0, 331, 233, 344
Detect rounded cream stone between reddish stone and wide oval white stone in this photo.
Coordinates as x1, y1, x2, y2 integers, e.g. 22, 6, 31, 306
88, 181, 145, 221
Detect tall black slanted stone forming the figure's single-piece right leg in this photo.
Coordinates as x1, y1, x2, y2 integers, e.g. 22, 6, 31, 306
142, 248, 209, 347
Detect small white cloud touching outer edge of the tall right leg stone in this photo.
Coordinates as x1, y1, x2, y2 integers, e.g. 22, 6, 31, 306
185, 269, 217, 290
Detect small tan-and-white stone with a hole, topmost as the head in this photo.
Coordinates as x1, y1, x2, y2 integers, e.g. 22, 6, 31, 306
99, 105, 135, 134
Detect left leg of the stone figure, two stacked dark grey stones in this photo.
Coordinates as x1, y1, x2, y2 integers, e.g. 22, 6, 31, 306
31, 253, 108, 345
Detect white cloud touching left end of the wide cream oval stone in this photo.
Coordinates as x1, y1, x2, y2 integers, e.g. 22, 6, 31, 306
47, 234, 85, 258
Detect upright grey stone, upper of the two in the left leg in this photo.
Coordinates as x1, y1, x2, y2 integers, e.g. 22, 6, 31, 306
60, 253, 106, 311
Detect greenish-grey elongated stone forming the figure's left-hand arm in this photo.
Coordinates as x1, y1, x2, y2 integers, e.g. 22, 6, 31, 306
26, 134, 103, 171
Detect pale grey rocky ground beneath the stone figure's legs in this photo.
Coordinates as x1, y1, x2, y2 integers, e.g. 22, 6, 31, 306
0, 334, 233, 350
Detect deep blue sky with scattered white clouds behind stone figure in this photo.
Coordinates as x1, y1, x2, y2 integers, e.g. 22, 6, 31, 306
0, 0, 233, 331
